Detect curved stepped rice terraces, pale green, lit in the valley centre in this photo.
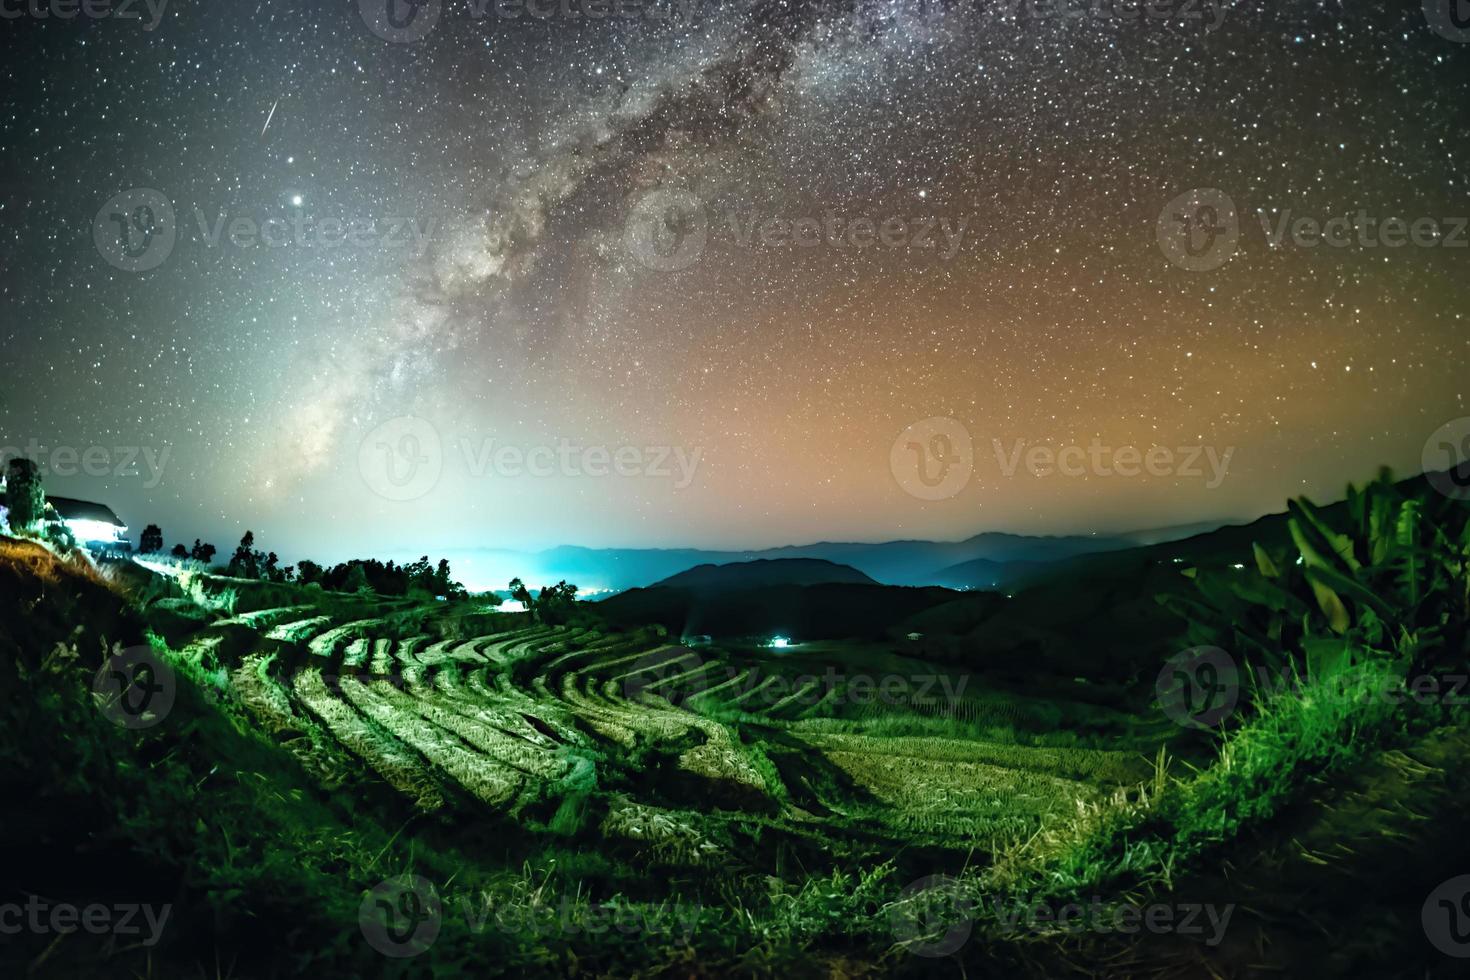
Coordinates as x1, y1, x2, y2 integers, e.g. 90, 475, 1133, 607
192, 605, 1148, 862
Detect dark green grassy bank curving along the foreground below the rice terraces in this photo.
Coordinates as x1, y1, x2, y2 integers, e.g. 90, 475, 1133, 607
0, 505, 1451, 977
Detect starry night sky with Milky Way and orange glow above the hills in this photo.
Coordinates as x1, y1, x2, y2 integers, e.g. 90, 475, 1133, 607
0, 0, 1470, 560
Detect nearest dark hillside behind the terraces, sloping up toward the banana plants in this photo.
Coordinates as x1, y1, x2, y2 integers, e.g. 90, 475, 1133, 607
597, 467, 1470, 688
